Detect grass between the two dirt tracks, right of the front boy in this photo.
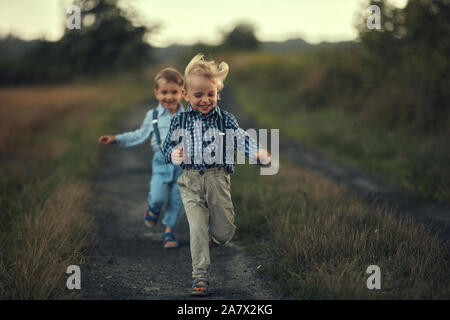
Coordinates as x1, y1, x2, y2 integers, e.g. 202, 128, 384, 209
232, 164, 450, 299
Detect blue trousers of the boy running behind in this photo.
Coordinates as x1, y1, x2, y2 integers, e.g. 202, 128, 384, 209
148, 151, 183, 229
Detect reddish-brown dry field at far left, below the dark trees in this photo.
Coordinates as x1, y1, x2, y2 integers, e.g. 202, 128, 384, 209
0, 85, 120, 154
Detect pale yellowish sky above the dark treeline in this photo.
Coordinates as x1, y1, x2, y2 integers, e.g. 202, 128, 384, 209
0, 0, 407, 46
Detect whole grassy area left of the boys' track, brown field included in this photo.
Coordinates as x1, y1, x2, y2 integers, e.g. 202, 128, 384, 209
0, 81, 151, 299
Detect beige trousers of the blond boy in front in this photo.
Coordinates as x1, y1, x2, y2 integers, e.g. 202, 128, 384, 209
177, 168, 236, 280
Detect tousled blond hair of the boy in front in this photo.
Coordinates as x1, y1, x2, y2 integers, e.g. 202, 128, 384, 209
184, 53, 229, 91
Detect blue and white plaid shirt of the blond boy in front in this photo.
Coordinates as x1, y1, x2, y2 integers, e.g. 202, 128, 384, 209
162, 104, 260, 173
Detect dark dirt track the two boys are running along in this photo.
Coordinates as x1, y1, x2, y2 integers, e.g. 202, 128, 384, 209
81, 102, 283, 300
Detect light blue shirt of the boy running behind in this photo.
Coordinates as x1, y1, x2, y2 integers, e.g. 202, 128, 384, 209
116, 103, 184, 151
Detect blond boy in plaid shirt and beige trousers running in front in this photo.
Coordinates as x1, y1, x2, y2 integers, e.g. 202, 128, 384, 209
163, 54, 270, 296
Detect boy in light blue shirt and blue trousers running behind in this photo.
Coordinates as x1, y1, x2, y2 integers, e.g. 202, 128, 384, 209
98, 68, 184, 248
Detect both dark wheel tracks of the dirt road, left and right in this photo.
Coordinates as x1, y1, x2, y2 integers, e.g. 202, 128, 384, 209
82, 90, 450, 300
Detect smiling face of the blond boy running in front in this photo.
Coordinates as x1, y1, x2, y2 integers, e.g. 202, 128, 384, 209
183, 75, 217, 114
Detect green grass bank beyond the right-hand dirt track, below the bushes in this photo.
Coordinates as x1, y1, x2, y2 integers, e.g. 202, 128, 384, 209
233, 81, 450, 202
